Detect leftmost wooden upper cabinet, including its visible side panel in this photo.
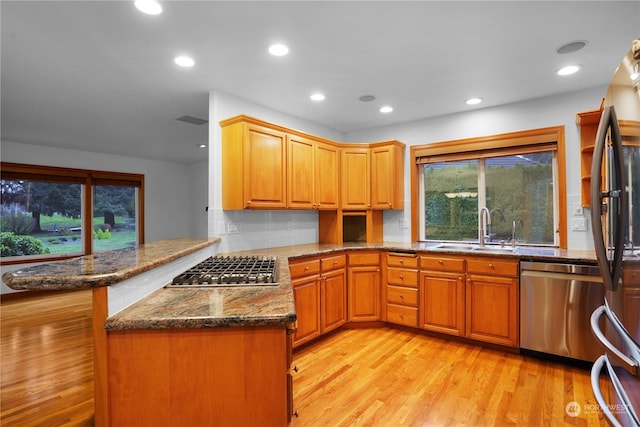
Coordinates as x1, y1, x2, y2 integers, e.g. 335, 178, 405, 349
221, 118, 287, 209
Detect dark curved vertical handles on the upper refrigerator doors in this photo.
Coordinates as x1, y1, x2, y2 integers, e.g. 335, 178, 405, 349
591, 106, 628, 291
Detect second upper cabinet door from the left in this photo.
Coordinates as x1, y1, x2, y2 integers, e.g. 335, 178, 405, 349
287, 135, 315, 209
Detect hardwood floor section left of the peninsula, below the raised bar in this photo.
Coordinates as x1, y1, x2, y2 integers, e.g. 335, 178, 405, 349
0, 291, 94, 427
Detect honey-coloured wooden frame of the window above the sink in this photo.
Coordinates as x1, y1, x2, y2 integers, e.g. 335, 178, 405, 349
410, 126, 567, 249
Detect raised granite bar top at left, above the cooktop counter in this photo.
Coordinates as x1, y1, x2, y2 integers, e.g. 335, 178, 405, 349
2, 238, 220, 290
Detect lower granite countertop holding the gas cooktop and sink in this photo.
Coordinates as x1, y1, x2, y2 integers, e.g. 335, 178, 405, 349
106, 242, 596, 330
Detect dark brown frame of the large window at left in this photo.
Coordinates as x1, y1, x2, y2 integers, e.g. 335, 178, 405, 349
0, 162, 144, 265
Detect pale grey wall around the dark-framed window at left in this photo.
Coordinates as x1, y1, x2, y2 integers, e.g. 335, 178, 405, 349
0, 141, 202, 293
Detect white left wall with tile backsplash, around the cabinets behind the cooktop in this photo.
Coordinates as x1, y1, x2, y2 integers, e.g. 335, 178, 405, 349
209, 91, 344, 252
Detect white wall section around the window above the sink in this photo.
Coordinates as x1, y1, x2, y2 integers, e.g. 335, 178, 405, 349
346, 86, 607, 249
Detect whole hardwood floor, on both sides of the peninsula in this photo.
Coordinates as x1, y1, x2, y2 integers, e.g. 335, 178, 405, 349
0, 291, 606, 427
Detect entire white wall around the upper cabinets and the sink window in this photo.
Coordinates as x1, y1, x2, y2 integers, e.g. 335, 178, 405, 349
209, 86, 606, 251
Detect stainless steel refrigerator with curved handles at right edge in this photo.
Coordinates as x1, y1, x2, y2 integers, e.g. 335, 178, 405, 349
591, 39, 640, 426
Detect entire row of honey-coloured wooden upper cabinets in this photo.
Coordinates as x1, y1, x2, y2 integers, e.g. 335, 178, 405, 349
220, 115, 405, 214
